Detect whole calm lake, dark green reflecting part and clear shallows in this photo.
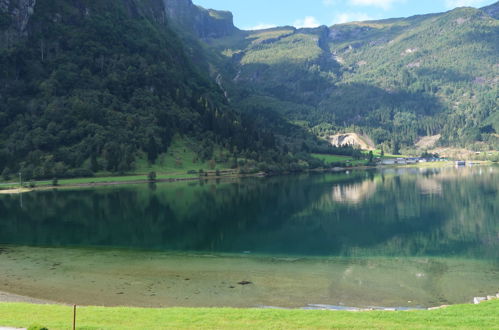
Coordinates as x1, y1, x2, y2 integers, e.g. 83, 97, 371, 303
0, 167, 499, 307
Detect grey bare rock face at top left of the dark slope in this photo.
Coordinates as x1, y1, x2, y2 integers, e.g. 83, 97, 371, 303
0, 0, 36, 48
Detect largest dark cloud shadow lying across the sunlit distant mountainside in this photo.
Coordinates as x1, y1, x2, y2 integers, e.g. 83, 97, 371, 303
230, 58, 446, 127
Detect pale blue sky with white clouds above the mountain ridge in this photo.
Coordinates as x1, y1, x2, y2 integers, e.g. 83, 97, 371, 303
193, 0, 497, 29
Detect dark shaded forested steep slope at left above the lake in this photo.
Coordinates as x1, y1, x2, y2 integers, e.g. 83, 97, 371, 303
0, 0, 332, 179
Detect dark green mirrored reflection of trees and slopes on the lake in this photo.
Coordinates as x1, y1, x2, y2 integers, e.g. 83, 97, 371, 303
0, 169, 499, 258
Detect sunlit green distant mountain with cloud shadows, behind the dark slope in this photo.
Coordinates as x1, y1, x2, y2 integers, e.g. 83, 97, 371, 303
207, 3, 499, 151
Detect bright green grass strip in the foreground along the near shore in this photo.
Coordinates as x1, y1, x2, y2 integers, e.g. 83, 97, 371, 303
0, 300, 499, 330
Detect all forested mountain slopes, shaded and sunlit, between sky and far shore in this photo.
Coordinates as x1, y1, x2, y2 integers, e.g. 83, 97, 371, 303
0, 0, 499, 178
